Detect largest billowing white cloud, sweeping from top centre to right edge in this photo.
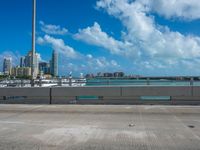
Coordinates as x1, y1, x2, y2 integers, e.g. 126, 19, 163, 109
90, 0, 200, 74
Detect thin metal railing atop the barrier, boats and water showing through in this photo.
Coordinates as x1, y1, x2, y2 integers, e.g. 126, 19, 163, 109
0, 77, 200, 87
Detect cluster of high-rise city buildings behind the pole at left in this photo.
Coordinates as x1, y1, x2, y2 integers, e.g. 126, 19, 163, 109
1, 50, 59, 79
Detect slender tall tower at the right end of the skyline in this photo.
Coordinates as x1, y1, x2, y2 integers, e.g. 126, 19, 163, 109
50, 50, 58, 77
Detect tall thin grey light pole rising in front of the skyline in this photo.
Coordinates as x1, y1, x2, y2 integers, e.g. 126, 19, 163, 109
31, 0, 36, 86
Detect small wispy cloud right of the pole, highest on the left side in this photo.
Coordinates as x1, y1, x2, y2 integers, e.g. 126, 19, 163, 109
40, 21, 68, 35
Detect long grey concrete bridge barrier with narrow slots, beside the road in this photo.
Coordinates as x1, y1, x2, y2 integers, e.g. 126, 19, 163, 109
0, 86, 200, 104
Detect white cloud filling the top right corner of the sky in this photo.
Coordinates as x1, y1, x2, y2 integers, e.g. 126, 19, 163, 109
137, 0, 200, 20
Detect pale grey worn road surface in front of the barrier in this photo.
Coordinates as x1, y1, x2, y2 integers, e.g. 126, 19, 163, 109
0, 105, 200, 150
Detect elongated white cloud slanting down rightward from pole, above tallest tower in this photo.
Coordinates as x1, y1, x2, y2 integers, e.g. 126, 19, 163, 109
37, 35, 81, 59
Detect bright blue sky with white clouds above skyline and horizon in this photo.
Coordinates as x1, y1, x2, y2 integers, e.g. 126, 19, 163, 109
0, 0, 200, 76
